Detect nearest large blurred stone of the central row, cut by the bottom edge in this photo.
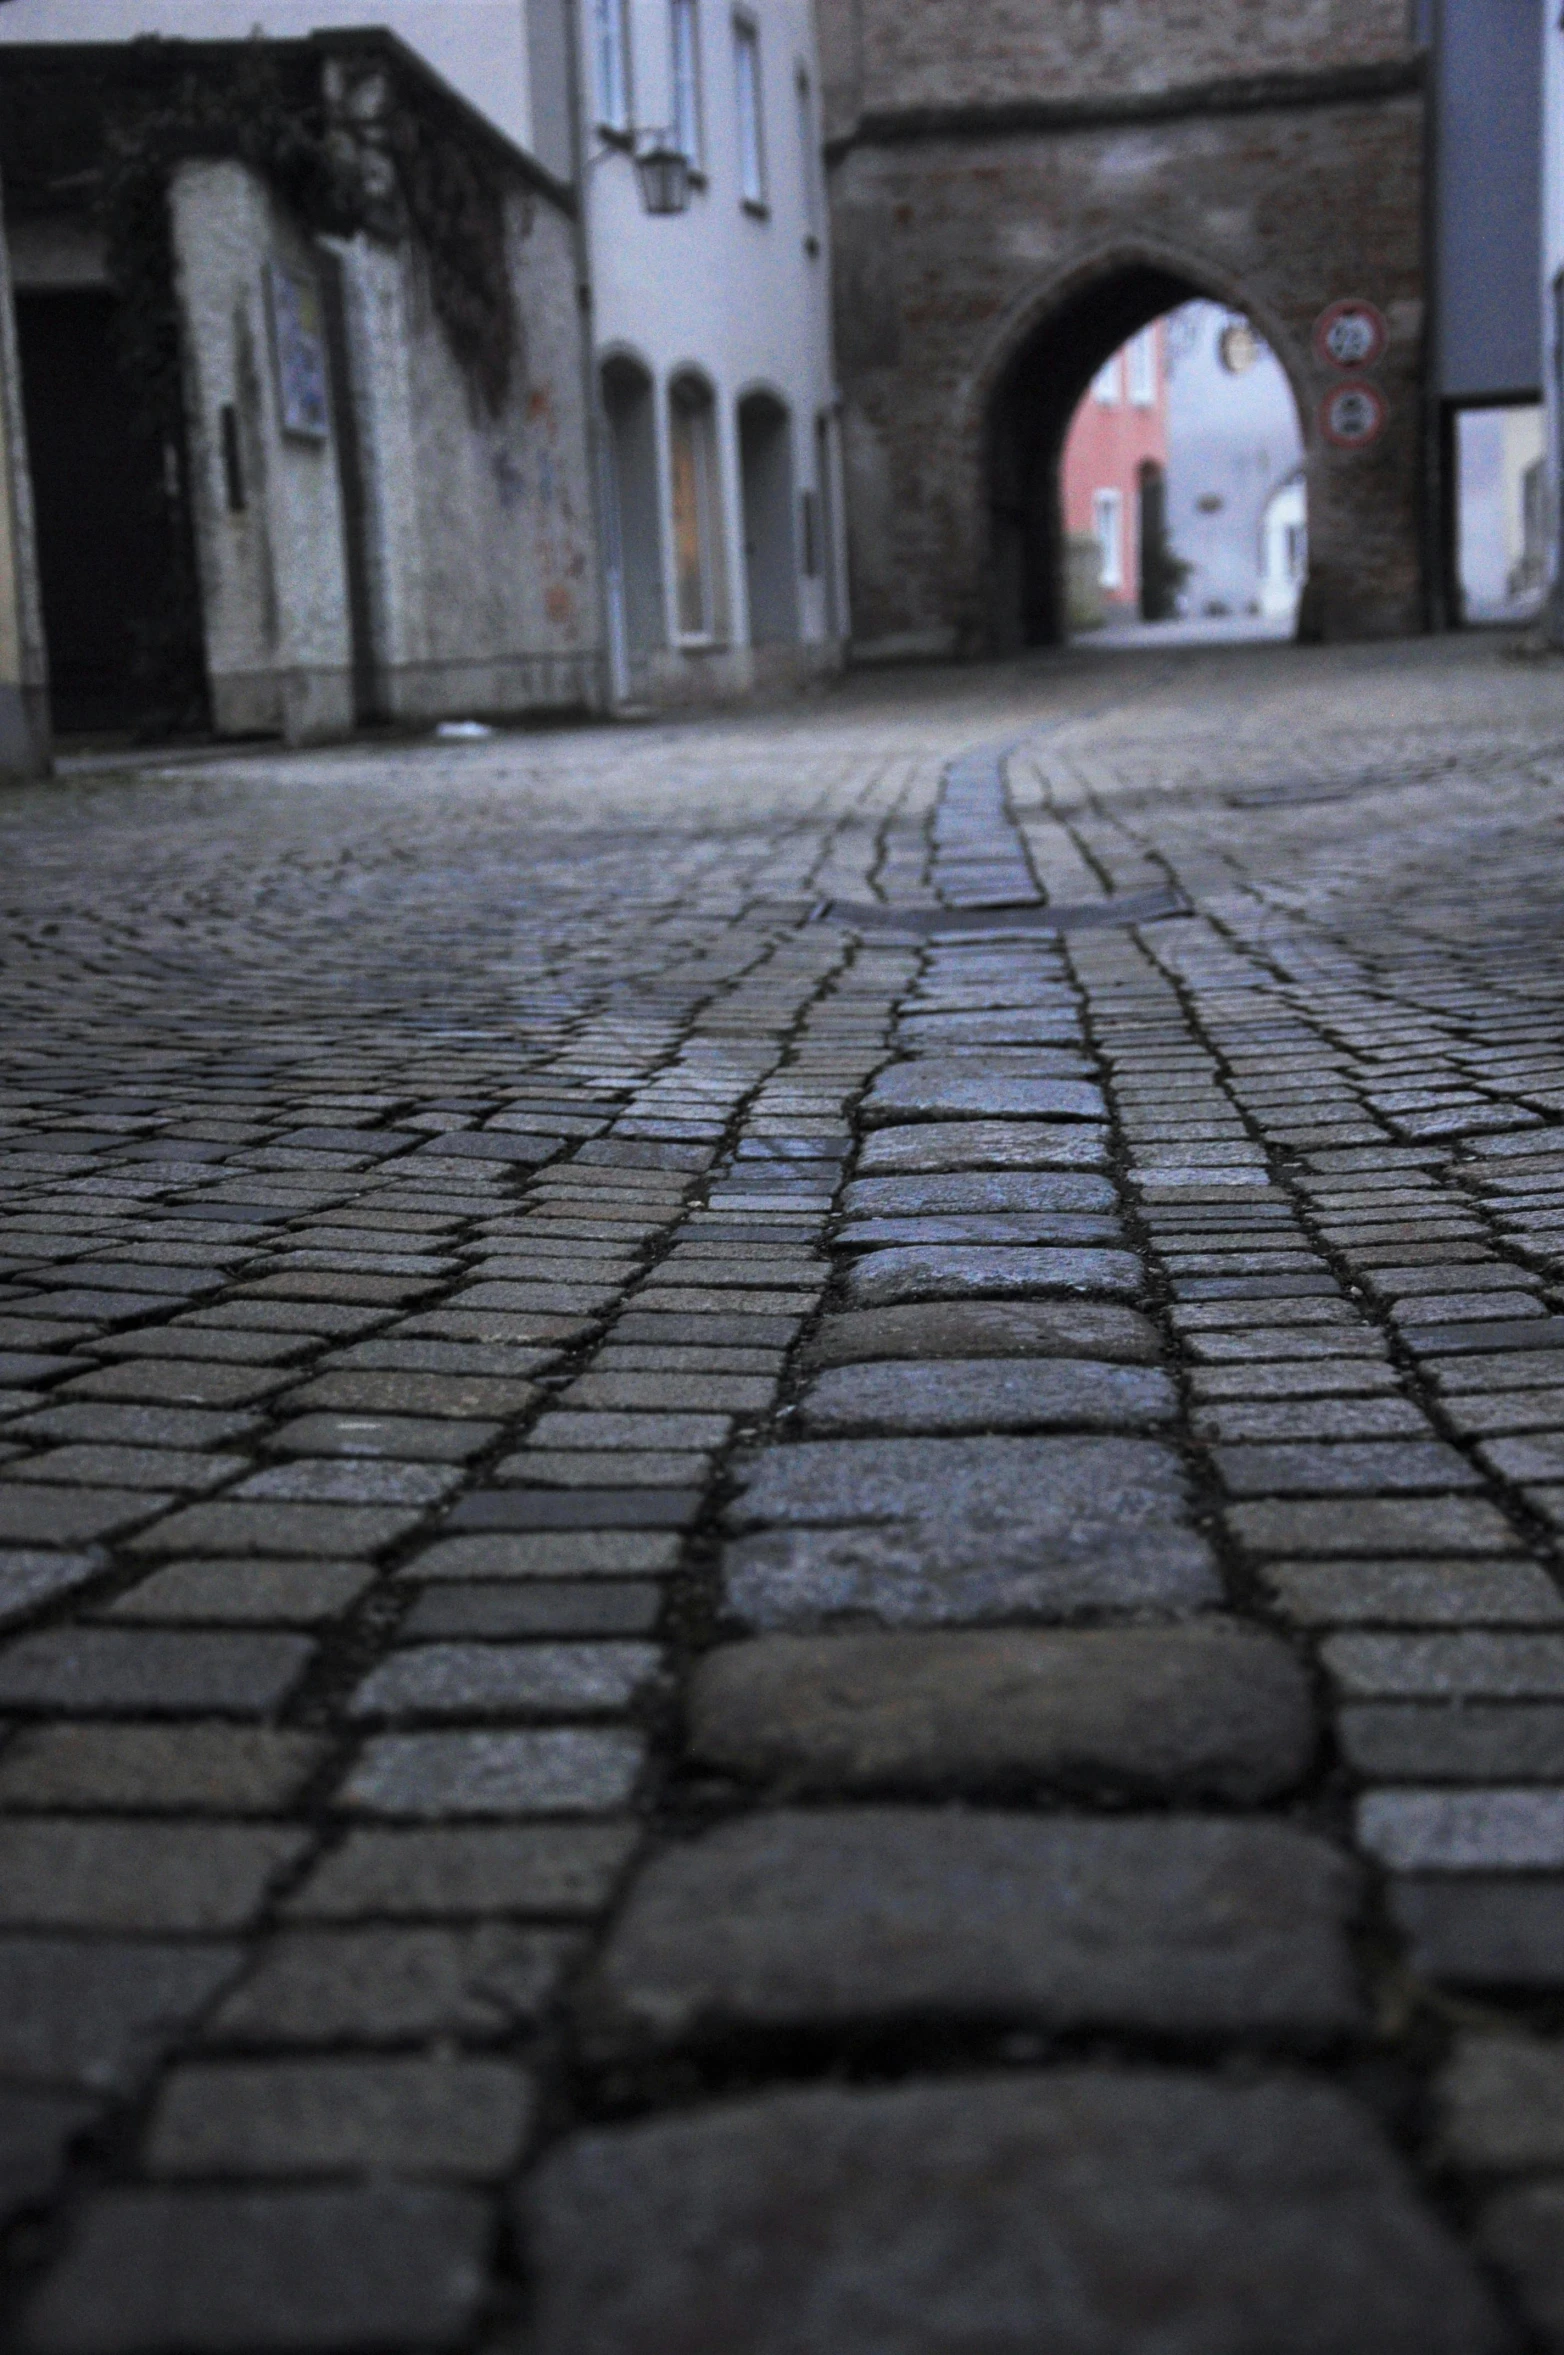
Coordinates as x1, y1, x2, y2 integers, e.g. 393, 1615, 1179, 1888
525, 2068, 1512, 2355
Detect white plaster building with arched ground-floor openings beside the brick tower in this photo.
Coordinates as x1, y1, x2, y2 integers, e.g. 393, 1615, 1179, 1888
572, 0, 846, 702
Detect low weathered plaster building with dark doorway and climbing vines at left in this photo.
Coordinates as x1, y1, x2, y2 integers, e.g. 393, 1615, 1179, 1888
0, 33, 605, 742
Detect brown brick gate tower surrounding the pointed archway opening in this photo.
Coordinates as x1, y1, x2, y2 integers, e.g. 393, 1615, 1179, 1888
822, 0, 1427, 655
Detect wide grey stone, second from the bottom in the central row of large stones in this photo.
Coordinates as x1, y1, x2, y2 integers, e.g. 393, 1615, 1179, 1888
582, 1806, 1359, 2056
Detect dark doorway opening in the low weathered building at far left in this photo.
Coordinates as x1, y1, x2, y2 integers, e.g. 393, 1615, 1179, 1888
16, 287, 203, 735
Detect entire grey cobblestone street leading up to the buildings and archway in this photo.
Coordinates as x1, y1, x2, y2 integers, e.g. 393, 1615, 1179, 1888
0, 638, 1564, 2355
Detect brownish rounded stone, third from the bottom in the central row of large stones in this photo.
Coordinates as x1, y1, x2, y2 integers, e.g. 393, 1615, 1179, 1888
690, 1620, 1314, 1804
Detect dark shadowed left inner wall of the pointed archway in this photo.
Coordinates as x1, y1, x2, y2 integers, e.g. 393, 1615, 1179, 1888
989, 264, 1201, 652
